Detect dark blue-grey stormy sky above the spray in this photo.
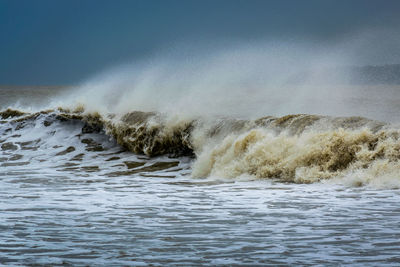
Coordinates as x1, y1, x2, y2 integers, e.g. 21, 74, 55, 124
0, 0, 400, 85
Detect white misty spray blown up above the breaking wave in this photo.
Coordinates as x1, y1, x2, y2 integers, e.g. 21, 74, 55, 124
51, 41, 400, 121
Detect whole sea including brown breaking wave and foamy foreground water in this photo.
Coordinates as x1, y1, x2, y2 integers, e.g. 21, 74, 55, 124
0, 84, 400, 266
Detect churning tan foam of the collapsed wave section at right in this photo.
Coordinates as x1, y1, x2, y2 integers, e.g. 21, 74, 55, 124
193, 128, 400, 187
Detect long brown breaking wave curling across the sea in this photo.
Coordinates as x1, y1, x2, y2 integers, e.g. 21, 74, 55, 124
0, 107, 400, 187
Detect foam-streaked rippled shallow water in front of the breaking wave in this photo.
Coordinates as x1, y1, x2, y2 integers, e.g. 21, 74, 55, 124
0, 155, 400, 266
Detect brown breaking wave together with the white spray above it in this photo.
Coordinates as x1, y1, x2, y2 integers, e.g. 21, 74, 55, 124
2, 42, 400, 184
